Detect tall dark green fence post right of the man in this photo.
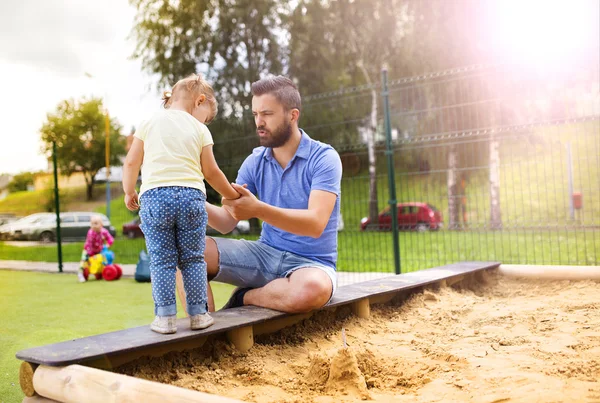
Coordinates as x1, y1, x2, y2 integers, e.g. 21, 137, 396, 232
381, 68, 401, 274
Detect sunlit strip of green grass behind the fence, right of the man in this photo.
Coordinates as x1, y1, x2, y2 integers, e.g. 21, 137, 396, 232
338, 229, 600, 272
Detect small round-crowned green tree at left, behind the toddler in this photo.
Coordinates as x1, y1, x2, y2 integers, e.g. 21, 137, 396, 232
40, 98, 125, 200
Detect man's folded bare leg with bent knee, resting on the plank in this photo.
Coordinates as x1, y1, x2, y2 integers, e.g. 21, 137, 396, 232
244, 267, 333, 313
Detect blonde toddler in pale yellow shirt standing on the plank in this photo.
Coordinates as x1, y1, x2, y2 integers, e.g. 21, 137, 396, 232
123, 74, 239, 334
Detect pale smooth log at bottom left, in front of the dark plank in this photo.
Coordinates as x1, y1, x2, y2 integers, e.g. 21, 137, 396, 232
33, 365, 240, 403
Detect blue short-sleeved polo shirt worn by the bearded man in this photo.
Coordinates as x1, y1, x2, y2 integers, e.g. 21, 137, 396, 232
236, 129, 342, 269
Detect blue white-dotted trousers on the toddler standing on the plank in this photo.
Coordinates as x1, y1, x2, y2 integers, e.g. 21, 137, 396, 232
140, 186, 208, 316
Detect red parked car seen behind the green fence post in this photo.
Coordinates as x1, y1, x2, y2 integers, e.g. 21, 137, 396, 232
360, 202, 444, 231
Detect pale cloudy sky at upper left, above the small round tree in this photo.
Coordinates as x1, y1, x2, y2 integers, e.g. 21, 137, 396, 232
0, 0, 160, 174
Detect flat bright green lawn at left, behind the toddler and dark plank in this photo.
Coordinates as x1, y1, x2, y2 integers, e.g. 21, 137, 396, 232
0, 270, 232, 403
